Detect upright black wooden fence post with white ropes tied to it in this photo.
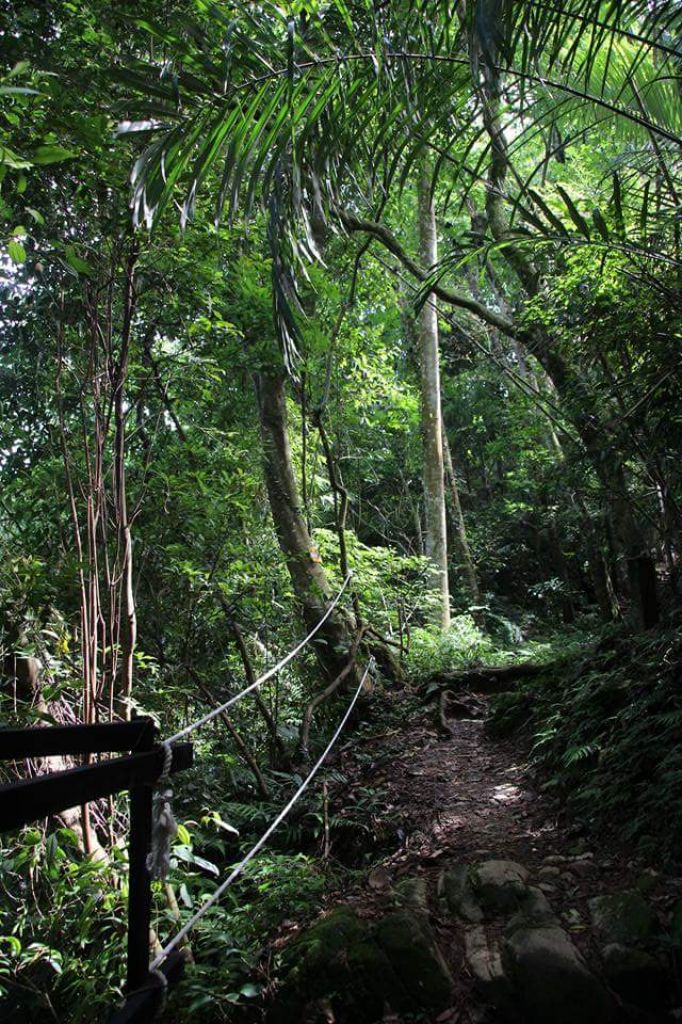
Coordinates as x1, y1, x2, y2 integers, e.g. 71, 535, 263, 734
126, 720, 154, 992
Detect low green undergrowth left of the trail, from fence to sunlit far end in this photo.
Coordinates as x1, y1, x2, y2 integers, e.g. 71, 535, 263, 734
0, 609, 598, 1024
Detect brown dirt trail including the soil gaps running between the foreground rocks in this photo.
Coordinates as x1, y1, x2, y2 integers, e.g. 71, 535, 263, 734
303, 696, 669, 1024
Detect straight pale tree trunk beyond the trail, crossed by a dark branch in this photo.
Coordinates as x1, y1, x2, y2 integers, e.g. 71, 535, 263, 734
418, 167, 450, 630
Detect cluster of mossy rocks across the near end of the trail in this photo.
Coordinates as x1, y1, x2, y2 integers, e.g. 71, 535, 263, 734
270, 855, 682, 1024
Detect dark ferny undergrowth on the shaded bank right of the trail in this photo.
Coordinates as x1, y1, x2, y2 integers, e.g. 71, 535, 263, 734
489, 625, 682, 864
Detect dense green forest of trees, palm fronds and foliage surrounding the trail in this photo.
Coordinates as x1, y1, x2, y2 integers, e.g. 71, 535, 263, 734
0, 0, 682, 1022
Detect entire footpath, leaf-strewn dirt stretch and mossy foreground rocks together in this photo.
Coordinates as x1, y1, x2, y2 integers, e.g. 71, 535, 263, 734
272, 694, 682, 1024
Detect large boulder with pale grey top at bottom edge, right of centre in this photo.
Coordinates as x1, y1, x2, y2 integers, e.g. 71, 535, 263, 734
503, 925, 613, 1024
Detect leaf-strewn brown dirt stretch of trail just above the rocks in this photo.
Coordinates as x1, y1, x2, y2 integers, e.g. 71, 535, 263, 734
339, 698, 577, 873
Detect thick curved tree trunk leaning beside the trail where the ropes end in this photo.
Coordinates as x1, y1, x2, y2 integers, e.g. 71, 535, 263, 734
256, 373, 354, 683
